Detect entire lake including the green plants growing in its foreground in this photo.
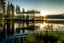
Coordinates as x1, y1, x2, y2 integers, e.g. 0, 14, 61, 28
0, 21, 64, 43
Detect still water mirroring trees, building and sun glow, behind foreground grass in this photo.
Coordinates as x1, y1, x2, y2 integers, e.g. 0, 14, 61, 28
0, 21, 64, 43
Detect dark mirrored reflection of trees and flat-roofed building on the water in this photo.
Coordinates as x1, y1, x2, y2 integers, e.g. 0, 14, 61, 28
0, 21, 35, 41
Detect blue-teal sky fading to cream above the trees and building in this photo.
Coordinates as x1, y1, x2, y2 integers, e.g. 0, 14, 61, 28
6, 0, 64, 14
